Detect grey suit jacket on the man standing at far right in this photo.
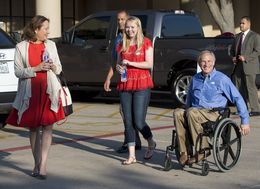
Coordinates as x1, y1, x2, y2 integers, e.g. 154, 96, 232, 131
231, 30, 260, 74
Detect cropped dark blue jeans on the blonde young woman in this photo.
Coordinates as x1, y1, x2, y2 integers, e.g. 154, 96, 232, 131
120, 89, 153, 146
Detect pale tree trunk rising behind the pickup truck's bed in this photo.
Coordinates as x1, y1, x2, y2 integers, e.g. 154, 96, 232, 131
205, 0, 235, 33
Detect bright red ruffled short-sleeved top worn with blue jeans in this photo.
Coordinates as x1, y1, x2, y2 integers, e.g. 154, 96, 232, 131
117, 37, 153, 91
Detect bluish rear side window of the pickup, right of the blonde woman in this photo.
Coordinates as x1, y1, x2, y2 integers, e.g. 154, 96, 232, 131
161, 15, 203, 38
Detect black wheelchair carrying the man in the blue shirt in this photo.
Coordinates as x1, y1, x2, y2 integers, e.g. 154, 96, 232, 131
164, 108, 241, 176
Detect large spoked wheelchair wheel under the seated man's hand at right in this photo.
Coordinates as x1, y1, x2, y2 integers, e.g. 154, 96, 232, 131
213, 118, 241, 172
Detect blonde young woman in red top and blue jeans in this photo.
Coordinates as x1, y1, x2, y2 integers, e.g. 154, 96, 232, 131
116, 16, 156, 165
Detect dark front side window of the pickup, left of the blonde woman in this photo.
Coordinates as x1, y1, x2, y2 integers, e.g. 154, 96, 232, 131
73, 17, 110, 43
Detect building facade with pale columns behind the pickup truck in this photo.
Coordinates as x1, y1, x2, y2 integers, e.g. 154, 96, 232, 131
0, 0, 260, 38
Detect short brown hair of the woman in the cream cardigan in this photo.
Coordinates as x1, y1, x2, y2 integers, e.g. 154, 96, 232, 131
22, 15, 50, 42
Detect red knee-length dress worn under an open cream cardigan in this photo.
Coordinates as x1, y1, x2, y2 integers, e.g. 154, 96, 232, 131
6, 43, 65, 128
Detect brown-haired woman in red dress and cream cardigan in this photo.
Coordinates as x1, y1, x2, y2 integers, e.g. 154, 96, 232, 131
6, 16, 65, 179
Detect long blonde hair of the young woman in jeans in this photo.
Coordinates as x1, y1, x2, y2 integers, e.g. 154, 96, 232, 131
121, 16, 144, 52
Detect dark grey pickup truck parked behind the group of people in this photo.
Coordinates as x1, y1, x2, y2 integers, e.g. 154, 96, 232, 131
57, 10, 233, 105
